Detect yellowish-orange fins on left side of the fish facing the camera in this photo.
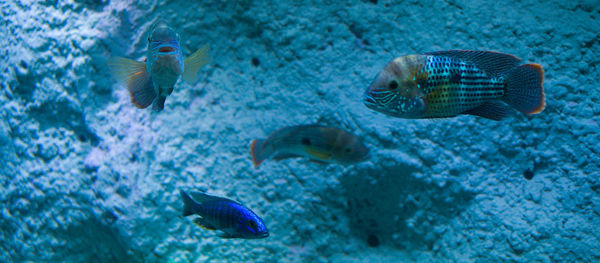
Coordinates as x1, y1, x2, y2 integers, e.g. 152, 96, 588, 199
108, 57, 156, 109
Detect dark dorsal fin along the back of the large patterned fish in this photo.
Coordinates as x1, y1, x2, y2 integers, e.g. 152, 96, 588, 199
425, 50, 521, 77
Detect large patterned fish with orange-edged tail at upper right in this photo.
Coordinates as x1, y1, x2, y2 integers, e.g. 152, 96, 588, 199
363, 50, 546, 121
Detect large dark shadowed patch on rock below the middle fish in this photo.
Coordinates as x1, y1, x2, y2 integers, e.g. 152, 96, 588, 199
340, 157, 474, 252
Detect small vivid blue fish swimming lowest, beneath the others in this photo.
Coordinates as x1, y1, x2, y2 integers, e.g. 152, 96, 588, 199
180, 190, 269, 239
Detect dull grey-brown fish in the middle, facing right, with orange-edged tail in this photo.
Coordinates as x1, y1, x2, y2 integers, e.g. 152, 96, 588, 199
250, 125, 369, 168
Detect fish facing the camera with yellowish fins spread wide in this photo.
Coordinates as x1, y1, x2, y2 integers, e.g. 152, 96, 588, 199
108, 20, 210, 111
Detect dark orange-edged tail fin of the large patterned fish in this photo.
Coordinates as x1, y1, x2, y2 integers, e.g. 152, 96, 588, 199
503, 64, 546, 115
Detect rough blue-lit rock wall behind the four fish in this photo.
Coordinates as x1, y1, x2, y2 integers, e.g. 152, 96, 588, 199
0, 0, 600, 262
